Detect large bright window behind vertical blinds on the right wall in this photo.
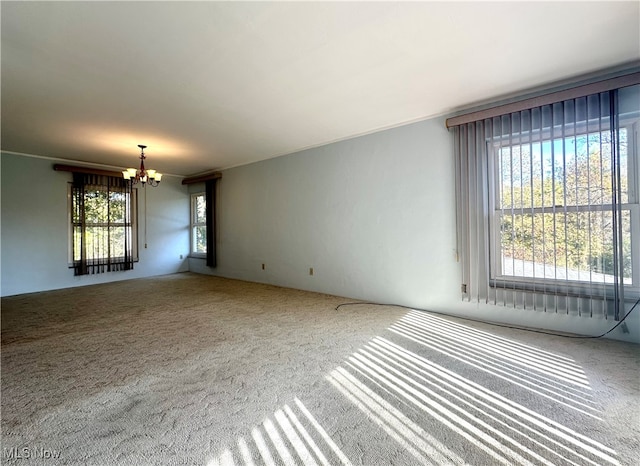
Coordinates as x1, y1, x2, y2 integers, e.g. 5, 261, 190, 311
489, 115, 640, 289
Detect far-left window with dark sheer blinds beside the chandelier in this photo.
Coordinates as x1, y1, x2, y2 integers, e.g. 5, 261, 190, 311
69, 173, 137, 275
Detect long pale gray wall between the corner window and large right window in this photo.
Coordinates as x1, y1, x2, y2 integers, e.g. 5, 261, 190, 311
189, 118, 640, 342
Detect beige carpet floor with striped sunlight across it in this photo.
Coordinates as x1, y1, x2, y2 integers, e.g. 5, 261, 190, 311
1, 274, 640, 465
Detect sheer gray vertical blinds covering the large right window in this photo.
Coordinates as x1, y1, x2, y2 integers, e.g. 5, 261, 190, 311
453, 85, 640, 319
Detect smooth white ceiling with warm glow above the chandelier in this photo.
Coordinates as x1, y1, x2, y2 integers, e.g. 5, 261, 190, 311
0, 1, 640, 175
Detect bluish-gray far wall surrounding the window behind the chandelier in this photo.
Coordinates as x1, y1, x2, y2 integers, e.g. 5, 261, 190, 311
0, 153, 189, 296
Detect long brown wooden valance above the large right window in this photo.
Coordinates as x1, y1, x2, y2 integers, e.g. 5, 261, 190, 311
446, 72, 640, 128
